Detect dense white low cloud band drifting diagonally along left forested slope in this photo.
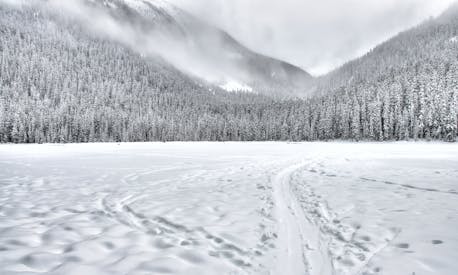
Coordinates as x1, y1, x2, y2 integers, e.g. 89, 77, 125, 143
47, 0, 233, 82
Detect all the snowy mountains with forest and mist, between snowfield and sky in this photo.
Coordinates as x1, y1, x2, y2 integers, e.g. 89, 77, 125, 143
0, 0, 458, 143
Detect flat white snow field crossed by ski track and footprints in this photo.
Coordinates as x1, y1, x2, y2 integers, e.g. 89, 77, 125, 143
0, 142, 458, 275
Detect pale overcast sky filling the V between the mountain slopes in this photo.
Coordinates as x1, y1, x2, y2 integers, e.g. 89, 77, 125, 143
172, 0, 454, 75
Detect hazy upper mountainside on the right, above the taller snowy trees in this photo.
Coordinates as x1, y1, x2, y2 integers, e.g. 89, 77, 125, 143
313, 2, 458, 96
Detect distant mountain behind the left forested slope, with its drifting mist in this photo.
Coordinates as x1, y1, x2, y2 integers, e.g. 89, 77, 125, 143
28, 0, 311, 96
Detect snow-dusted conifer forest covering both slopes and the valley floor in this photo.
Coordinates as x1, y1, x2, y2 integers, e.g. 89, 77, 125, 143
0, 2, 458, 143
